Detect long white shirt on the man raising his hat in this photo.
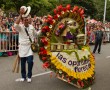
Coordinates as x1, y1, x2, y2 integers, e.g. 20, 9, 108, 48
14, 24, 37, 57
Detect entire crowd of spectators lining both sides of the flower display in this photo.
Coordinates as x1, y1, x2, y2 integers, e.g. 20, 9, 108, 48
0, 15, 110, 56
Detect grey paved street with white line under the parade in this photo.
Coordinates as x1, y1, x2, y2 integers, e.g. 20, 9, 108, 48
0, 43, 110, 90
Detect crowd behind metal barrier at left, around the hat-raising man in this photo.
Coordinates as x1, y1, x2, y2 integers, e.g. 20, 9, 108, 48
0, 15, 46, 56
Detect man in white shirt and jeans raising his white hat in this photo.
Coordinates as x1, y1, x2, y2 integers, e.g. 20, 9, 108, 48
14, 6, 37, 82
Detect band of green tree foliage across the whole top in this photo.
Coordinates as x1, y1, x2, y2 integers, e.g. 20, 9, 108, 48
0, 0, 110, 21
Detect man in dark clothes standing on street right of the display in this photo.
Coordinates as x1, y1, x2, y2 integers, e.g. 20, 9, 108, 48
93, 26, 103, 54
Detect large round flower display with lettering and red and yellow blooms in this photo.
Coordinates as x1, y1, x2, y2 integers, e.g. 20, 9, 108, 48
39, 5, 95, 88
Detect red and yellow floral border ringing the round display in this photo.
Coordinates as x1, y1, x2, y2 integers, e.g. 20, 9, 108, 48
39, 4, 95, 88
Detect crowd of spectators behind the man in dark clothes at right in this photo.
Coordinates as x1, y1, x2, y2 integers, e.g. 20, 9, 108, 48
86, 22, 110, 44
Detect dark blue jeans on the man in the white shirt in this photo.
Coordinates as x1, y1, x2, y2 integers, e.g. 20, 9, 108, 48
21, 55, 33, 79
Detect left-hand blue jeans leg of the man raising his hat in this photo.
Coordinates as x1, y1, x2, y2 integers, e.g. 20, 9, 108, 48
21, 57, 26, 79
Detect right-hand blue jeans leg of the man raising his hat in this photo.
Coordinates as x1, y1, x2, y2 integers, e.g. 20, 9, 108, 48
27, 55, 33, 78
